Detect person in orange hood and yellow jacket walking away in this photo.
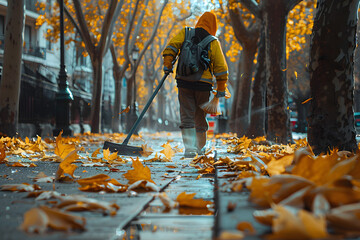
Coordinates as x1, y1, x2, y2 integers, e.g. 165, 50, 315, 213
163, 12, 228, 158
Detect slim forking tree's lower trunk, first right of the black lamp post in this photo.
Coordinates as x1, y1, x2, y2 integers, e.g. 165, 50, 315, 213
91, 54, 103, 133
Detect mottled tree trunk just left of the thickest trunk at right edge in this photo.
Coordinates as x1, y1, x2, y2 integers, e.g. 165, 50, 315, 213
263, 0, 292, 144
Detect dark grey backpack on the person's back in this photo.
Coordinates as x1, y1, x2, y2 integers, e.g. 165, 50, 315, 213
176, 27, 217, 81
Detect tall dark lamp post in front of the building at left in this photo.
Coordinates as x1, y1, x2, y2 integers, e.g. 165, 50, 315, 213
53, 0, 74, 136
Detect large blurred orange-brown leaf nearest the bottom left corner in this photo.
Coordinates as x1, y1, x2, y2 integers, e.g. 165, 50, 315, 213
20, 206, 86, 233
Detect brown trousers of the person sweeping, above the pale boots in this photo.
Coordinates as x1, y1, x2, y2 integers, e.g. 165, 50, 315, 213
178, 88, 210, 132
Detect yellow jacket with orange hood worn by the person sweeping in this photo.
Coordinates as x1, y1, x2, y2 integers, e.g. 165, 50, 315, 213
163, 12, 228, 87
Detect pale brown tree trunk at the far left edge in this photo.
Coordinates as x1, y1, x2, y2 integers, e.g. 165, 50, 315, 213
0, 0, 25, 137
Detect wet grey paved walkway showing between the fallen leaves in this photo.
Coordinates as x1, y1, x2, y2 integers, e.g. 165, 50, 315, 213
0, 132, 269, 240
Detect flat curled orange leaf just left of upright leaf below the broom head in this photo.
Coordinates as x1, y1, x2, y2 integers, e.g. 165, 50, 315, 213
77, 174, 127, 192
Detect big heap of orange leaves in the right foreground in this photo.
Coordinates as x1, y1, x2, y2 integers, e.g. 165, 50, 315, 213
210, 137, 360, 239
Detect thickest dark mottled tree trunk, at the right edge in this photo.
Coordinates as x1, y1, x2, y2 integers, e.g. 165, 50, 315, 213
308, 0, 359, 154
